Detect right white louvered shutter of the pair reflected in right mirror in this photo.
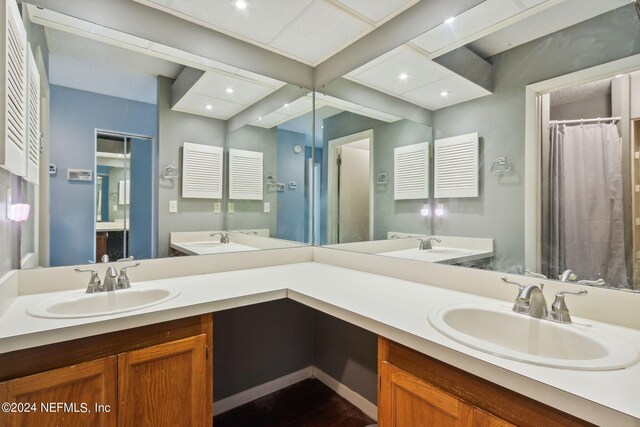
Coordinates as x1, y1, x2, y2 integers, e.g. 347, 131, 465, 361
433, 132, 478, 198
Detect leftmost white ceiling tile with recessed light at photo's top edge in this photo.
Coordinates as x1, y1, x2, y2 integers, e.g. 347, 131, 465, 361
147, 0, 312, 44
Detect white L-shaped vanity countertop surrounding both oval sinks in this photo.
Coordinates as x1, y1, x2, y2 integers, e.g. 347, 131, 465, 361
0, 262, 640, 426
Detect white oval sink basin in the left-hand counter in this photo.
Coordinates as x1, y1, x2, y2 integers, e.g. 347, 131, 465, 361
27, 287, 180, 319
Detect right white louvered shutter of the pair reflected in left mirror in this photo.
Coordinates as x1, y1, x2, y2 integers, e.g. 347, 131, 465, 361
229, 149, 264, 200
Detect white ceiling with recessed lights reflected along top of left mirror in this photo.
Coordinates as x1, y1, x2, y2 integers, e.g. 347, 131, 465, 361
27, 5, 284, 120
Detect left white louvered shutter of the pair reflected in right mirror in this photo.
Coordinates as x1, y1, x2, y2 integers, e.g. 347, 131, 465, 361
393, 142, 429, 200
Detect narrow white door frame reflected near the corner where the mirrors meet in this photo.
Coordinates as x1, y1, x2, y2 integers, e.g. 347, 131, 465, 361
327, 129, 375, 244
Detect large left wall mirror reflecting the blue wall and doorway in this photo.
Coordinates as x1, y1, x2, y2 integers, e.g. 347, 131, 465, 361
7, 3, 312, 268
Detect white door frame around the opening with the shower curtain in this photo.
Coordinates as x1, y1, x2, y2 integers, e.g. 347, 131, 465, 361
524, 54, 640, 271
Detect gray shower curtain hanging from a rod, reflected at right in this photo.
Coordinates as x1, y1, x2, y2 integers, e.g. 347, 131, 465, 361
547, 123, 628, 286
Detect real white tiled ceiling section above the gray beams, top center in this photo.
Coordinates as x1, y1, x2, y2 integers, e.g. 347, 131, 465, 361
136, 0, 418, 66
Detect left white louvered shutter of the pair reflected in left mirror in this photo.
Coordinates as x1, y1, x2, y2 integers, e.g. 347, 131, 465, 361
182, 142, 224, 199
